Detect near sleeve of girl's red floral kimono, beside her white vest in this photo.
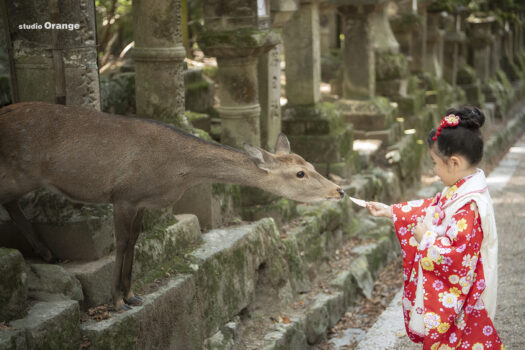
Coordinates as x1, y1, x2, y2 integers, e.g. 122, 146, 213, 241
418, 201, 483, 295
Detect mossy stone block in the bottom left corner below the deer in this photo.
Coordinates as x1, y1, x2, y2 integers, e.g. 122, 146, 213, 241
0, 300, 80, 350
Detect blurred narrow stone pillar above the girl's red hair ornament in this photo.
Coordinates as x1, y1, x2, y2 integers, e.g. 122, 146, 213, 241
425, 12, 444, 79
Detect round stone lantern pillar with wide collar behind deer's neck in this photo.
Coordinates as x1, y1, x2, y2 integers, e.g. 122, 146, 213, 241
199, 0, 280, 147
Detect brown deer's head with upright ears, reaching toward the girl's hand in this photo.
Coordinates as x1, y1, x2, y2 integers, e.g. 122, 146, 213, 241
244, 134, 344, 202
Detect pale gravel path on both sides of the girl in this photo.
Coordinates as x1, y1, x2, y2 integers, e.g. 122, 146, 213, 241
352, 135, 525, 350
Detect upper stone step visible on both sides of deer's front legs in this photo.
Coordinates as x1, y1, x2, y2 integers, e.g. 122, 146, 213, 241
61, 214, 201, 308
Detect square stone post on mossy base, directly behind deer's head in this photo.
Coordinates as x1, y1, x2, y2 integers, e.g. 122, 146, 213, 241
282, 0, 353, 177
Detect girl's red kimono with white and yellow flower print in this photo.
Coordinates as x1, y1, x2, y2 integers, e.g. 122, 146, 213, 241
392, 175, 504, 350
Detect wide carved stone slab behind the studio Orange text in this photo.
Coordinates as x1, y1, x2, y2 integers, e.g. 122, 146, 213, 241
6, 0, 100, 109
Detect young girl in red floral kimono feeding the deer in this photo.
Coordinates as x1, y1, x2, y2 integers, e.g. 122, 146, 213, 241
367, 107, 504, 350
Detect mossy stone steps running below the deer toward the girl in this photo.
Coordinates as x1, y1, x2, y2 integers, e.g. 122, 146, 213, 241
0, 187, 400, 349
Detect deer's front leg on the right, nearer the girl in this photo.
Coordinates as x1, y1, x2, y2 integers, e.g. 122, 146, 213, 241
121, 208, 144, 305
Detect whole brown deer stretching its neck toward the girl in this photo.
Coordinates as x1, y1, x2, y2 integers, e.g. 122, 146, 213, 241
0, 102, 344, 311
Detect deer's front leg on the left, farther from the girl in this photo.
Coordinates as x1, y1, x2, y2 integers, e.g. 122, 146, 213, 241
111, 203, 137, 311
